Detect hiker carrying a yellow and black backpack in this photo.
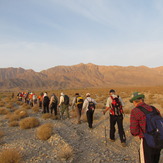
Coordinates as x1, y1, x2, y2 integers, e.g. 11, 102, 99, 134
72, 93, 84, 124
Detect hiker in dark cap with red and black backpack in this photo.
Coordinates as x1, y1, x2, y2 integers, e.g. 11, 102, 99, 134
103, 89, 126, 147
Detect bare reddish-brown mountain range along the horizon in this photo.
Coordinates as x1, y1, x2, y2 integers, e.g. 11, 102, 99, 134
0, 63, 163, 89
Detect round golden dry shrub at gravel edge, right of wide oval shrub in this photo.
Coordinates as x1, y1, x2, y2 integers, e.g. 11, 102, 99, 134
36, 123, 53, 140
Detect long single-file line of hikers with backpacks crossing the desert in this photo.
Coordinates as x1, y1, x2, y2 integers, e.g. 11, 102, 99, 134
18, 89, 163, 163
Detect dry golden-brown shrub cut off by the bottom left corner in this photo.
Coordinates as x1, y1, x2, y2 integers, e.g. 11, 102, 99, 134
0, 149, 22, 163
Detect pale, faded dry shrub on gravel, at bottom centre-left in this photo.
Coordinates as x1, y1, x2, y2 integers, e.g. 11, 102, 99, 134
57, 144, 73, 160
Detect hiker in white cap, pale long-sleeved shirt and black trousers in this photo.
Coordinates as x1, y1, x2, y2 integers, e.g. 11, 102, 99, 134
82, 93, 96, 129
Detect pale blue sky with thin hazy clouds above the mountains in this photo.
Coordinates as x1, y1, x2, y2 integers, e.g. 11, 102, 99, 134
0, 0, 163, 72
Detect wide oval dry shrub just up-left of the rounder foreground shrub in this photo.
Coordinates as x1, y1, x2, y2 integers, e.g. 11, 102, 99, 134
19, 117, 40, 129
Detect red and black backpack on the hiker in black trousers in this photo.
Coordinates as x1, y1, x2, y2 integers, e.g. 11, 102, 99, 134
110, 96, 123, 115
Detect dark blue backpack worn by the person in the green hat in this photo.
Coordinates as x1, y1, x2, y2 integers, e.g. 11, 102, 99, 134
137, 106, 163, 149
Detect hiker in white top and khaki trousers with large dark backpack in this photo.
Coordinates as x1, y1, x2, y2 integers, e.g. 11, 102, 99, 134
58, 92, 70, 119
